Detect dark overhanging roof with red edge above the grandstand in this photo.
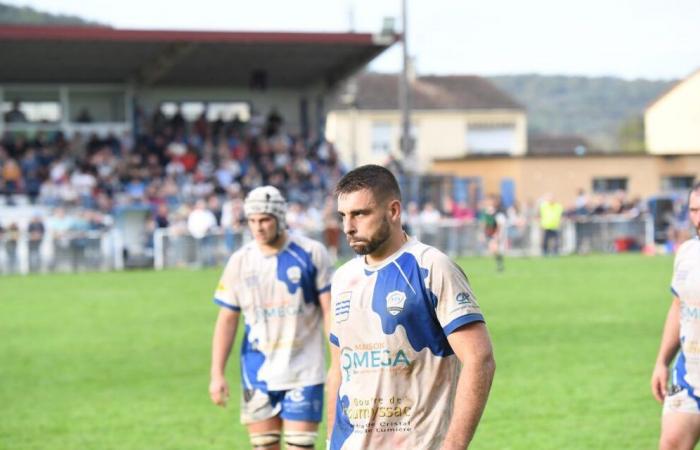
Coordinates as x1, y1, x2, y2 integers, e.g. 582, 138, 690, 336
0, 25, 397, 88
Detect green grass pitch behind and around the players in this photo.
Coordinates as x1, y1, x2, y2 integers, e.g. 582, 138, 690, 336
0, 255, 672, 450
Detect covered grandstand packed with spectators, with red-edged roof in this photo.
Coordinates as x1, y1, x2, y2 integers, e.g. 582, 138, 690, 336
0, 26, 397, 272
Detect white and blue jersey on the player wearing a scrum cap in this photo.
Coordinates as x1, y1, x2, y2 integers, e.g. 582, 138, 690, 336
214, 235, 332, 391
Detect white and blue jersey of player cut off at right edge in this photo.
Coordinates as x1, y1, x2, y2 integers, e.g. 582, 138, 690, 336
671, 239, 700, 396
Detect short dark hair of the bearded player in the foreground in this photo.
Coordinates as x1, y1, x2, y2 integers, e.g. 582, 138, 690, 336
335, 164, 401, 202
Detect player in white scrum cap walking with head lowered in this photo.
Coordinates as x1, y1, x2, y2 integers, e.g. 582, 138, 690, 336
209, 186, 332, 450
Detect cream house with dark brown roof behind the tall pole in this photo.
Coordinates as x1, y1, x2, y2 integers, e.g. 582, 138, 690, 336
326, 73, 527, 172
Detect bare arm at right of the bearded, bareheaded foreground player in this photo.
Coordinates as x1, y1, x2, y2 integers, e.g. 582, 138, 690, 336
442, 322, 496, 450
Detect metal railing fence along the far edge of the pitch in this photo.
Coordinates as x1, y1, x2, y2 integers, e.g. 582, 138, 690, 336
0, 217, 654, 274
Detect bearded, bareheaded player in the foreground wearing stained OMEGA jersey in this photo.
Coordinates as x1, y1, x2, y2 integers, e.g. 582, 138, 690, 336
327, 165, 495, 450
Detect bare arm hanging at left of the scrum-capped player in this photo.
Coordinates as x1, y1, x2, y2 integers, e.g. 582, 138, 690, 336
209, 308, 240, 406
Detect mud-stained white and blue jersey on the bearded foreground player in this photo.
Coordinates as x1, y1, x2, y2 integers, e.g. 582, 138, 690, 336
330, 239, 483, 450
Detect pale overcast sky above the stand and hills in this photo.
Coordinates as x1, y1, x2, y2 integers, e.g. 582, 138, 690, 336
5, 0, 700, 80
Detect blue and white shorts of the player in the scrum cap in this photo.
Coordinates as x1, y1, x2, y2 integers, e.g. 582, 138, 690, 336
241, 384, 323, 425
